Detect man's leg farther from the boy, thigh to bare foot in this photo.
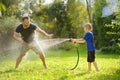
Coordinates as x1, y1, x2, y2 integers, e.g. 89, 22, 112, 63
15, 45, 29, 68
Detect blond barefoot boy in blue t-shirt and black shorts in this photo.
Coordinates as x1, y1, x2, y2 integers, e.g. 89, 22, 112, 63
73, 23, 99, 72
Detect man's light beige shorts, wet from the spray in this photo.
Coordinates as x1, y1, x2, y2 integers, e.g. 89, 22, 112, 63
20, 41, 44, 54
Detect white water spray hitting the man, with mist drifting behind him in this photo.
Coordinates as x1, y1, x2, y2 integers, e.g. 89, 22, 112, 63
0, 31, 70, 60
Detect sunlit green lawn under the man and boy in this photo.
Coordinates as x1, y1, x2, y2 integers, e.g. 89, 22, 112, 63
0, 45, 120, 80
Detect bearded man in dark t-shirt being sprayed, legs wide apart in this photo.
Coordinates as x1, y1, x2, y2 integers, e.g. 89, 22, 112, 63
13, 17, 52, 69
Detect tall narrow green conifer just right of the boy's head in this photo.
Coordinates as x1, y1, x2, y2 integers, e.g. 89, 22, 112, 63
93, 0, 105, 48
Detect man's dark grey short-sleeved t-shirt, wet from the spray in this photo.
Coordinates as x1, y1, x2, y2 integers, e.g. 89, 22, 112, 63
16, 23, 37, 43
